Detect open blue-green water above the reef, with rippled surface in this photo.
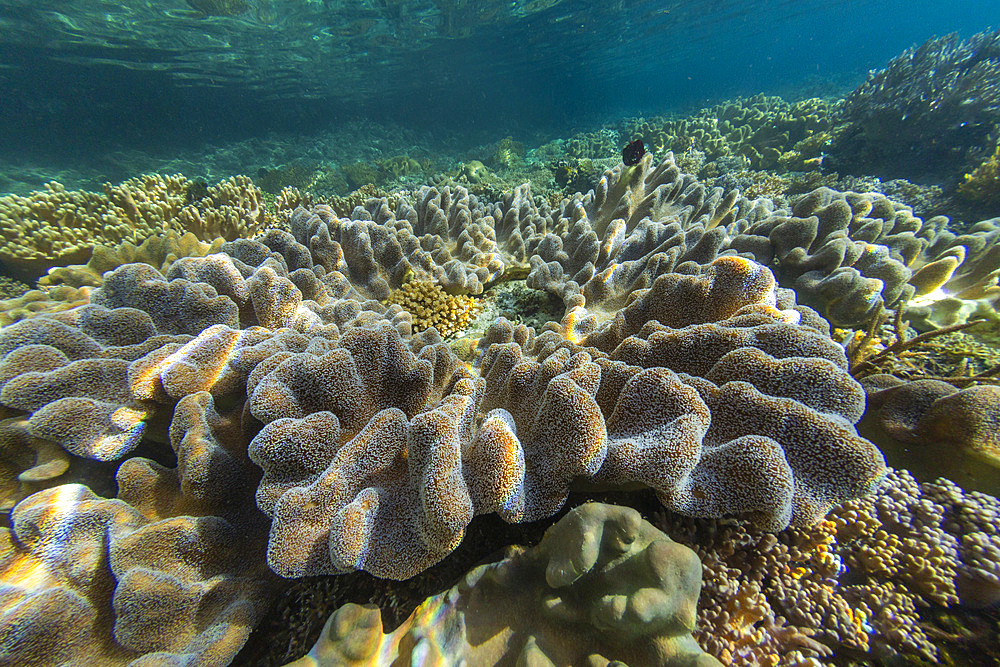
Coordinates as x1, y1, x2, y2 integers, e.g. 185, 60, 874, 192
0, 0, 1000, 157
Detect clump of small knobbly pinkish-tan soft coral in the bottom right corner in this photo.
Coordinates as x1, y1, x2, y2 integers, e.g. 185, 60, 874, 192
655, 470, 1000, 666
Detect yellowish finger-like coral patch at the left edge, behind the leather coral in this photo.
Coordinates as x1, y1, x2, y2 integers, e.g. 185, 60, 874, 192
0, 174, 266, 277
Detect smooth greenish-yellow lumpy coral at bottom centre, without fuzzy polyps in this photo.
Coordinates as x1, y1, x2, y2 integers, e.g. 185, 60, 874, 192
290, 503, 720, 667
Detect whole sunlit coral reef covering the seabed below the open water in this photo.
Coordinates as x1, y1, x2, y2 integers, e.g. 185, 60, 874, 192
0, 44, 1000, 666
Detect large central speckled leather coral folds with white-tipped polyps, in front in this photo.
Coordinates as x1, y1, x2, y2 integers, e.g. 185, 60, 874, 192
247, 257, 884, 579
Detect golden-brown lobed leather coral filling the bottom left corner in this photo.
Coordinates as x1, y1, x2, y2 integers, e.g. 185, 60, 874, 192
0, 393, 274, 665
